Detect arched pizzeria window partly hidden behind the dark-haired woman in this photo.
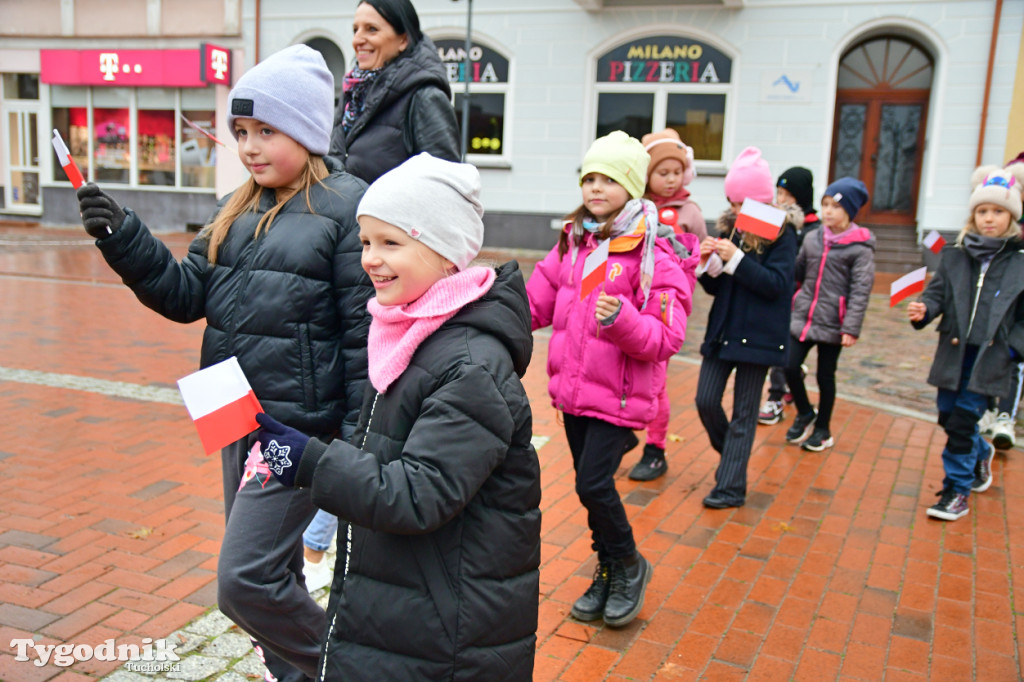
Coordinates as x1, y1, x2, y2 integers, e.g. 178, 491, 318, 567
434, 39, 509, 166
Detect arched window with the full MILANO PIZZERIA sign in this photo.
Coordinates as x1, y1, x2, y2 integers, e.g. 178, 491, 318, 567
595, 35, 732, 165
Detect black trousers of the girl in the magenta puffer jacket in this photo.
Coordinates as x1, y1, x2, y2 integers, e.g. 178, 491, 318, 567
562, 413, 637, 561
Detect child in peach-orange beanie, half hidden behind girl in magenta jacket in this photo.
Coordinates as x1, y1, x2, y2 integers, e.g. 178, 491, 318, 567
630, 128, 708, 480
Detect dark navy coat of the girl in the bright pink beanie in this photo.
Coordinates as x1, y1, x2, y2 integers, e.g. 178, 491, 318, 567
698, 207, 803, 367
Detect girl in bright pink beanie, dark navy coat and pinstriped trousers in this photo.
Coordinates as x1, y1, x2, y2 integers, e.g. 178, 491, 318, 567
696, 146, 803, 509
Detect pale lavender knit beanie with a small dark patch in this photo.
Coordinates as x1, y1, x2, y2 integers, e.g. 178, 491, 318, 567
227, 45, 334, 157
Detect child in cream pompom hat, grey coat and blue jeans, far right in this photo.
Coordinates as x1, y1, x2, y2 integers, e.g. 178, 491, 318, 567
907, 165, 1024, 521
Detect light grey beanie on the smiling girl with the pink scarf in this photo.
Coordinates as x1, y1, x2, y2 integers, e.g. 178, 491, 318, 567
355, 152, 483, 270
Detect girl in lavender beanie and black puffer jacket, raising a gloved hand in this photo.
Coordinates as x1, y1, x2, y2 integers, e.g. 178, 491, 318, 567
78, 45, 373, 681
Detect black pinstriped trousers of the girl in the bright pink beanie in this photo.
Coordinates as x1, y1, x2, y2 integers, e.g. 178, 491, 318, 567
697, 356, 768, 503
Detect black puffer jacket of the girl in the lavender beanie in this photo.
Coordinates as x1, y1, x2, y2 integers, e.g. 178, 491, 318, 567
96, 158, 373, 435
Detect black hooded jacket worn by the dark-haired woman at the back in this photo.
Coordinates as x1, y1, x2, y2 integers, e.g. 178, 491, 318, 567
331, 36, 460, 182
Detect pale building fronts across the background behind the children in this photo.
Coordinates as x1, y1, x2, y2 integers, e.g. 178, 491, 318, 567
0, 0, 1024, 269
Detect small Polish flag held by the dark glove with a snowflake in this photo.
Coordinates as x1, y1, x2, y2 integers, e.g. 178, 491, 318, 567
178, 355, 263, 455
